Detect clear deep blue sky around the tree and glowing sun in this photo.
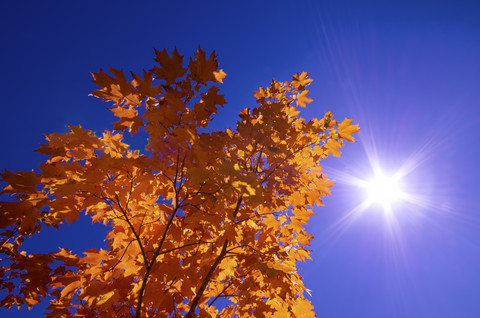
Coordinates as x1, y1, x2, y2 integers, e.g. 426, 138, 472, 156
0, 0, 480, 318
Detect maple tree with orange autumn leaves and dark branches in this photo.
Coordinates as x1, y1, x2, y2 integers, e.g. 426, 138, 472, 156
0, 49, 359, 317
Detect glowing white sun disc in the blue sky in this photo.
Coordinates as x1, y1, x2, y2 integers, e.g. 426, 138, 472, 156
365, 173, 403, 207
